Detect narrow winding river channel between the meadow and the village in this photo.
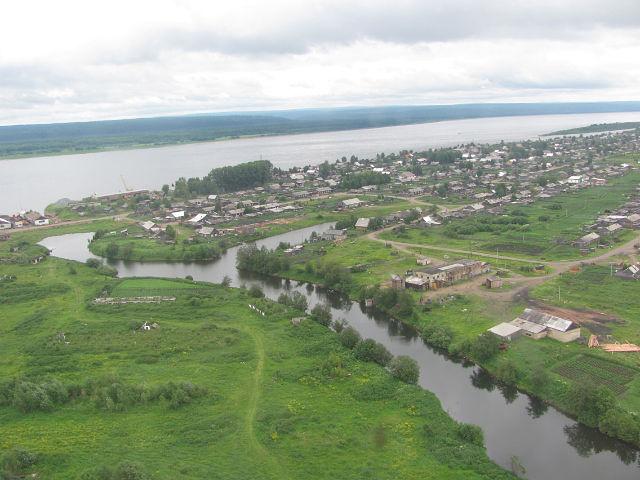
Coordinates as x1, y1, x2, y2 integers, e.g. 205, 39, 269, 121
41, 223, 640, 480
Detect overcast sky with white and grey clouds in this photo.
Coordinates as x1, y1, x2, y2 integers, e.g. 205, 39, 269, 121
0, 0, 640, 124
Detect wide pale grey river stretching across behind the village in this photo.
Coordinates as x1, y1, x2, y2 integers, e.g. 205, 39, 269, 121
0, 112, 640, 214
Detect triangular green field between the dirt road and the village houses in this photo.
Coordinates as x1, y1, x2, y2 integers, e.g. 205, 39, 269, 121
381, 172, 640, 260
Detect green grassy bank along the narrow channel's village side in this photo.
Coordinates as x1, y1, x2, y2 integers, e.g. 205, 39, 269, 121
234, 234, 640, 452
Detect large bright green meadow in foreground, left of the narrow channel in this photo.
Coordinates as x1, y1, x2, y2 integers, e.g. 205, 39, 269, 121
0, 258, 511, 480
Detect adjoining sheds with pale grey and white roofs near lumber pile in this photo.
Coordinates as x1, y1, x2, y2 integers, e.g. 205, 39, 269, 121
489, 308, 580, 343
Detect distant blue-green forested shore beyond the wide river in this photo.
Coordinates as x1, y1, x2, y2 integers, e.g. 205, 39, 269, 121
0, 102, 640, 158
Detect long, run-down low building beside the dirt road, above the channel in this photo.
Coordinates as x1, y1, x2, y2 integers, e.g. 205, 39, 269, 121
391, 259, 490, 290
